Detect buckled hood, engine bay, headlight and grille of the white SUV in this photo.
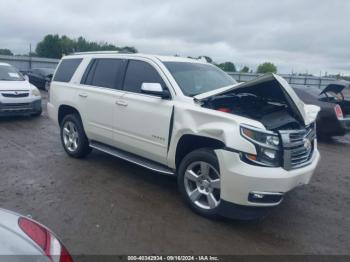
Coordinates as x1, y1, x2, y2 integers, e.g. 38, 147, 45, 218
195, 74, 319, 170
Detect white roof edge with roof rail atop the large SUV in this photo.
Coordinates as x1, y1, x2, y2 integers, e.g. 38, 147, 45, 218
62, 51, 207, 64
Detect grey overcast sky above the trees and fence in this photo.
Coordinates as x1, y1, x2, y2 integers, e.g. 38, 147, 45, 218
0, 0, 350, 75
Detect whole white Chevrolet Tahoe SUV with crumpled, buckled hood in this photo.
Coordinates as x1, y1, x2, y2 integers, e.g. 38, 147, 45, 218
47, 52, 320, 219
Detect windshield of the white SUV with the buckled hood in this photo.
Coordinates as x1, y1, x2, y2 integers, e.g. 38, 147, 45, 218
164, 62, 237, 96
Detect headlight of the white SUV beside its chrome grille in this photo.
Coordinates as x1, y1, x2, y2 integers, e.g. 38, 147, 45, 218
241, 126, 281, 167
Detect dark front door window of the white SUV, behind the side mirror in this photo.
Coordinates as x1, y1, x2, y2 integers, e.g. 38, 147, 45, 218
124, 60, 166, 93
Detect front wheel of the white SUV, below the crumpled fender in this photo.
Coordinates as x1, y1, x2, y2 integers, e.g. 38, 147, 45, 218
178, 149, 221, 218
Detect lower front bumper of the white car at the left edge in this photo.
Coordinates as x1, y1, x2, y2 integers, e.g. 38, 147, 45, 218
0, 99, 42, 117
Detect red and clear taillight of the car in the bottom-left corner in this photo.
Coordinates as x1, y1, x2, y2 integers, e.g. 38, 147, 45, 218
18, 217, 73, 262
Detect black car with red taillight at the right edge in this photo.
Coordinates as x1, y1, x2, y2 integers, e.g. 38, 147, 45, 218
293, 81, 350, 137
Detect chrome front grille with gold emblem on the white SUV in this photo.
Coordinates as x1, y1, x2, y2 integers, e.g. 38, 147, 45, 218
280, 124, 316, 170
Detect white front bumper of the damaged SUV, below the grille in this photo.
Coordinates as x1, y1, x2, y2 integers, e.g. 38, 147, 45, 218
215, 147, 320, 219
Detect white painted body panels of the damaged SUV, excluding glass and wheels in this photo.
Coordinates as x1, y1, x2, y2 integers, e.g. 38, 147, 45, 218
47, 53, 319, 210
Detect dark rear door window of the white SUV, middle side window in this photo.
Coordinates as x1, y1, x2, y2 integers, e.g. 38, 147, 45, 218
82, 58, 123, 88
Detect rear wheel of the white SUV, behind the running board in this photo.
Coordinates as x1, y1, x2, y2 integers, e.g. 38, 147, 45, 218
60, 114, 92, 158
